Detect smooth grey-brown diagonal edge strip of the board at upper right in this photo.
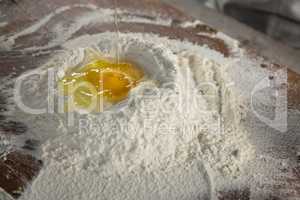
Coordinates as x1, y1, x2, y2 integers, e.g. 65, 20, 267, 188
163, 0, 300, 73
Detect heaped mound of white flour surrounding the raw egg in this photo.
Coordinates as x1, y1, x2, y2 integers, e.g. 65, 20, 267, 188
0, 33, 252, 199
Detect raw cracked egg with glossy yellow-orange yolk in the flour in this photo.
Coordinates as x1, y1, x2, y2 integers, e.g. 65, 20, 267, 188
59, 59, 144, 110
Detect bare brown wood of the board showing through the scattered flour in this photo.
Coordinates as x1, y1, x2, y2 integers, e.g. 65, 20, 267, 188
0, 0, 300, 200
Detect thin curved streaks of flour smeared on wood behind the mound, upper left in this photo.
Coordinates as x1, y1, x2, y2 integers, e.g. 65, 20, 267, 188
0, 4, 172, 51
